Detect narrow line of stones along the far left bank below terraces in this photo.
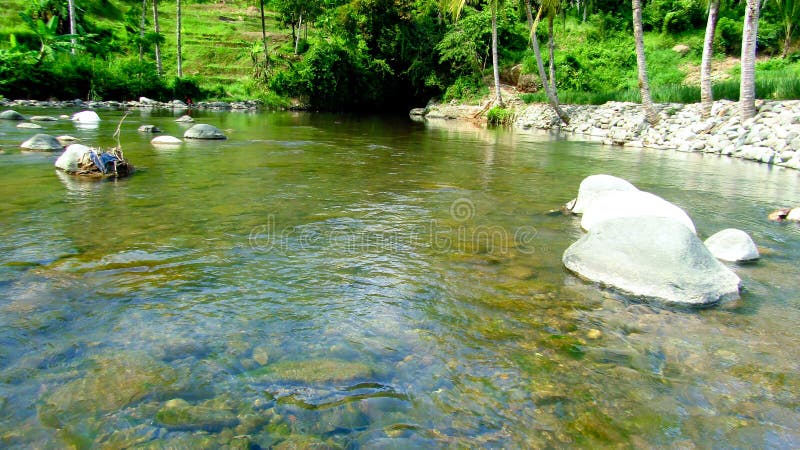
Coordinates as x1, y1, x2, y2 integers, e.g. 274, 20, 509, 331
0, 97, 264, 111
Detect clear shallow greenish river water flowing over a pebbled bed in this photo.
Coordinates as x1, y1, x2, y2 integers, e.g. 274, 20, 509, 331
0, 109, 800, 449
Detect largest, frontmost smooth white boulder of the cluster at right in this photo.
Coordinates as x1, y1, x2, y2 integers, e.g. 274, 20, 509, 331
562, 216, 740, 306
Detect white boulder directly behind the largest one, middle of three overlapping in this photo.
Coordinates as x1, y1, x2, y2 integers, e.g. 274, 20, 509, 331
581, 191, 697, 234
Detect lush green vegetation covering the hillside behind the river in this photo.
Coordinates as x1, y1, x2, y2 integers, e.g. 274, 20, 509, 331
0, 0, 800, 111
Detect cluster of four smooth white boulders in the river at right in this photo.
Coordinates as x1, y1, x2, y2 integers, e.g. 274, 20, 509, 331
562, 175, 758, 306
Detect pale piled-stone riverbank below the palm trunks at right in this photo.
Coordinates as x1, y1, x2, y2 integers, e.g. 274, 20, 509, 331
411, 100, 800, 170
